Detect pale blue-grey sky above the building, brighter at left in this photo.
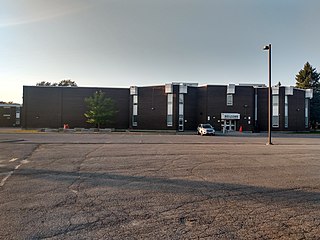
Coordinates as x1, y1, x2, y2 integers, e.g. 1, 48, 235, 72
0, 0, 320, 103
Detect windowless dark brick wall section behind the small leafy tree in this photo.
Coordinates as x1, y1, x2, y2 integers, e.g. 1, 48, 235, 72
22, 86, 129, 129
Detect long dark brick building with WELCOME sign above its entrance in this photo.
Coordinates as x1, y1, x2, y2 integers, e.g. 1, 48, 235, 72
22, 83, 312, 131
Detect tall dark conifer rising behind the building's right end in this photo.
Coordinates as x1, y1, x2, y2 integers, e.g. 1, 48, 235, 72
296, 62, 320, 127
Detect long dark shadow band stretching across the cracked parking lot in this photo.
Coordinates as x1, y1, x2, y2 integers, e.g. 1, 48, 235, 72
8, 168, 320, 207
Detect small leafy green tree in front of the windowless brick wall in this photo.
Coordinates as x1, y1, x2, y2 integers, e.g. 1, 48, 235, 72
84, 91, 117, 130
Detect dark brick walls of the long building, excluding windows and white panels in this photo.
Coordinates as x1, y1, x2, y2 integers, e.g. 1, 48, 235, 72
22, 85, 306, 131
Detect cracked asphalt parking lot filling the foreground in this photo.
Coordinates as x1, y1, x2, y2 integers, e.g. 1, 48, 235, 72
0, 133, 320, 239
